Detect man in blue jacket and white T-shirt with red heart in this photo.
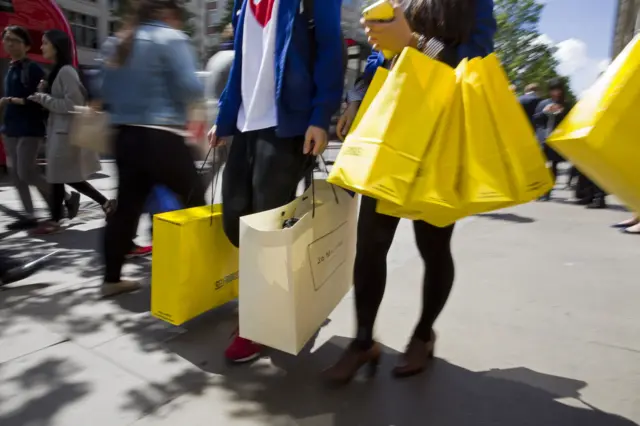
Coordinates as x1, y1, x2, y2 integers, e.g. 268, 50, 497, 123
209, 0, 344, 362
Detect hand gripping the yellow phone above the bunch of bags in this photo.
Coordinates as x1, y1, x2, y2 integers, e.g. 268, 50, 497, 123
361, 3, 413, 53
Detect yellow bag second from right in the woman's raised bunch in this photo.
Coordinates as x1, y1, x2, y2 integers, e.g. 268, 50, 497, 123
460, 58, 520, 216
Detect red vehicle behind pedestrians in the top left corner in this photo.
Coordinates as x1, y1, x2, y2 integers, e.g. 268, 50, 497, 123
0, 0, 77, 166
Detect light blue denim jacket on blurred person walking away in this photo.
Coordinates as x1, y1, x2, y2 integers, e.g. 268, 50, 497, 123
101, 21, 204, 127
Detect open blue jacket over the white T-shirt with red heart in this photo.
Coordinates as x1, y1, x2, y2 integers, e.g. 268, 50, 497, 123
217, 0, 344, 138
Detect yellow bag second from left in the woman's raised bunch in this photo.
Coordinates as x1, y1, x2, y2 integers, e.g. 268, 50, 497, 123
376, 60, 467, 227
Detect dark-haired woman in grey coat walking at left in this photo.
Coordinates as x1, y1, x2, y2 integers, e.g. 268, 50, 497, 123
29, 30, 115, 235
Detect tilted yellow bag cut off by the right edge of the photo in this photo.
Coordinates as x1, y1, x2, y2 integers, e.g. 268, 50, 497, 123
548, 36, 640, 211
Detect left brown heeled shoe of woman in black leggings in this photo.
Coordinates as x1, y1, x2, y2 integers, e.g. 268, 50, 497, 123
322, 343, 381, 386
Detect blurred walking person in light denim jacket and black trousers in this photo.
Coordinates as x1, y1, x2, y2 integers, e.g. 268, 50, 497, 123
101, 0, 205, 297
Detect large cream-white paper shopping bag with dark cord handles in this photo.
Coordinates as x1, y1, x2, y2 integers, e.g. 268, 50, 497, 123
239, 180, 358, 355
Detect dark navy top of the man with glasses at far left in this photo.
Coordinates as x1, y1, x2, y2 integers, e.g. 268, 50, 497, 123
2, 61, 46, 138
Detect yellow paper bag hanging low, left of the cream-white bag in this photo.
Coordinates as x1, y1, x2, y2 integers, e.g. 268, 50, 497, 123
151, 205, 238, 325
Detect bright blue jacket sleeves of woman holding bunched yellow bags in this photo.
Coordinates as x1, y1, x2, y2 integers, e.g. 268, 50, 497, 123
362, 0, 497, 84
